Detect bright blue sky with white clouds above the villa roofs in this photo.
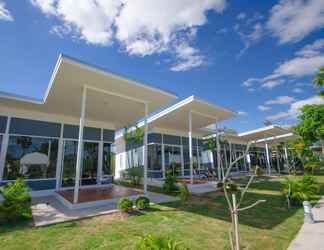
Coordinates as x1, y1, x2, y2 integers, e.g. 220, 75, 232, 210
0, 0, 324, 131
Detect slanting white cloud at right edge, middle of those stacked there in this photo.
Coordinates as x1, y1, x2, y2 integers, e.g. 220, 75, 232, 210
243, 39, 324, 89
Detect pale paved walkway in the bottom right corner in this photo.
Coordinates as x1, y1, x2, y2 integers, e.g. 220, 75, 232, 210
288, 197, 324, 250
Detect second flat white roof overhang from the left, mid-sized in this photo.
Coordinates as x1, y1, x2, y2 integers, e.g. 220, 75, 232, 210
143, 96, 237, 135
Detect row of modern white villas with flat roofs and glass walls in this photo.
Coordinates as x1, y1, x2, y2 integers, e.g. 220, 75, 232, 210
0, 55, 293, 203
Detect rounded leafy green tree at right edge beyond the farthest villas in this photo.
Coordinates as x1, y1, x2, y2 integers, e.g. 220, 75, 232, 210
294, 104, 324, 155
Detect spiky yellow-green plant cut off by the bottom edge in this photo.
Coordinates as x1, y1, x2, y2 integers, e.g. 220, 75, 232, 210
135, 234, 189, 250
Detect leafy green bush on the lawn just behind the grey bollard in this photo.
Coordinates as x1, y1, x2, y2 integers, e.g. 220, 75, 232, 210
282, 175, 319, 206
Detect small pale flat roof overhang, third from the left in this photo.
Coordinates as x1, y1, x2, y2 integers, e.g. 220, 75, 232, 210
238, 125, 291, 142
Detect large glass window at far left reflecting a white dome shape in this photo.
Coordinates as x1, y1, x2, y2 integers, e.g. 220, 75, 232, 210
4, 136, 58, 180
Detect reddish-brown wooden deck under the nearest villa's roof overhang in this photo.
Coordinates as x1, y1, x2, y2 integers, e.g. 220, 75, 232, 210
57, 185, 143, 203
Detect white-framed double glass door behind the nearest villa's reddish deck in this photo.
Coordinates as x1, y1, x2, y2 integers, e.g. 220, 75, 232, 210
61, 140, 99, 187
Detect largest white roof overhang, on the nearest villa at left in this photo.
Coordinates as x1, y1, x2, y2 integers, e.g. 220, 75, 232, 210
0, 55, 176, 129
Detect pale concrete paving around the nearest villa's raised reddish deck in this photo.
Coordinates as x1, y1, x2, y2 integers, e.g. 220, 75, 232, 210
32, 192, 179, 227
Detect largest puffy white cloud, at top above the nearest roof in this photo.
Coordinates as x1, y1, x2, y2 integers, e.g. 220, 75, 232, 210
31, 0, 226, 71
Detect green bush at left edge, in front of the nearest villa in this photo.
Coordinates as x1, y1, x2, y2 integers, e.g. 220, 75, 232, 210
0, 179, 32, 223
